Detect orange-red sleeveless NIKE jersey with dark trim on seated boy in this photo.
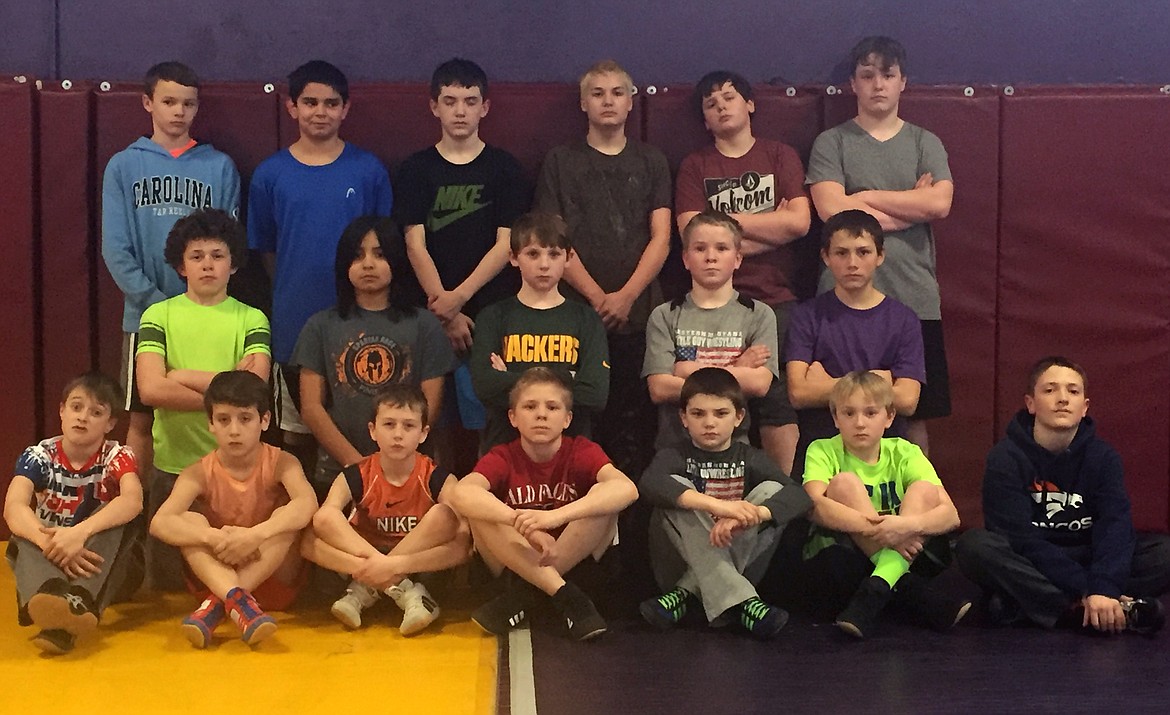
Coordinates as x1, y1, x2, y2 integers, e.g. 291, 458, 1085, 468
342, 453, 450, 551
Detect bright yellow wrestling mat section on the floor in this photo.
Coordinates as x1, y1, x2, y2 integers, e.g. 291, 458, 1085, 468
0, 542, 496, 715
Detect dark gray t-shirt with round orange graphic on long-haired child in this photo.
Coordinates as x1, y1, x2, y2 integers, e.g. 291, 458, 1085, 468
293, 307, 455, 479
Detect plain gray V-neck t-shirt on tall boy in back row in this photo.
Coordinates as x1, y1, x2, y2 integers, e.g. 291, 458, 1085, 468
805, 119, 951, 321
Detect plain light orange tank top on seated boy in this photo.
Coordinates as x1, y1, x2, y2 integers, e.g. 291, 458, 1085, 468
199, 444, 289, 529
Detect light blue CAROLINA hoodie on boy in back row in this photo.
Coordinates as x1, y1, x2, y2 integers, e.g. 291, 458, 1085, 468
102, 137, 240, 332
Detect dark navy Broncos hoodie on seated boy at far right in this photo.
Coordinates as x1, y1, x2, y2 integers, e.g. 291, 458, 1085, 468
983, 410, 1135, 598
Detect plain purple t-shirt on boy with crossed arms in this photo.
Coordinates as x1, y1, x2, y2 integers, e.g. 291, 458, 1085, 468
785, 290, 927, 477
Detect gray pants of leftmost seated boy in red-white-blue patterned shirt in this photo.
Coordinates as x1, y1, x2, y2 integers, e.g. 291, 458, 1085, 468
5, 524, 143, 614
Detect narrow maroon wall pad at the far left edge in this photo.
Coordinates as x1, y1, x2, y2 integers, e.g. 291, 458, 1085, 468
0, 81, 39, 538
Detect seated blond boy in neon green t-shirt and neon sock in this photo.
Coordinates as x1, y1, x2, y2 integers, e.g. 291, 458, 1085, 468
803, 371, 971, 638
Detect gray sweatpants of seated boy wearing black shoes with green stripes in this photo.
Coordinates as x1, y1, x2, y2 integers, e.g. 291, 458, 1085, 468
649, 476, 784, 623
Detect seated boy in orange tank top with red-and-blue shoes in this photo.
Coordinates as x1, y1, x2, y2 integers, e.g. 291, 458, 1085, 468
150, 370, 317, 648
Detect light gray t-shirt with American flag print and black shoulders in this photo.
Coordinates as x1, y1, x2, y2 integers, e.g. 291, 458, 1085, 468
642, 293, 780, 449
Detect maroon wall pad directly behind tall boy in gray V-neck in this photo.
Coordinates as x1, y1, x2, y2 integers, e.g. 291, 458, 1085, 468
825, 87, 1002, 527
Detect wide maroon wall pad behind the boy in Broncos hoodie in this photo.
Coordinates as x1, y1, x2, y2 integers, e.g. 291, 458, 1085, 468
997, 88, 1170, 531
